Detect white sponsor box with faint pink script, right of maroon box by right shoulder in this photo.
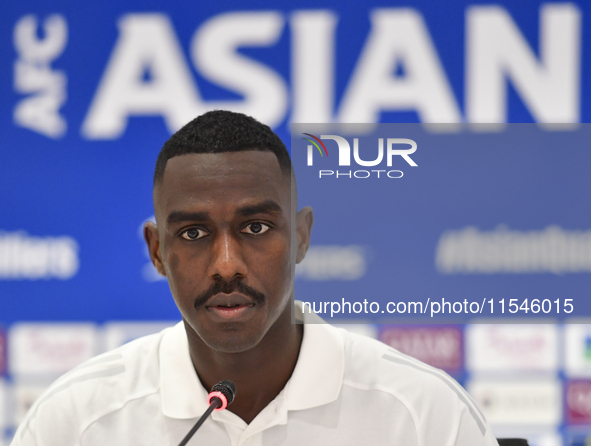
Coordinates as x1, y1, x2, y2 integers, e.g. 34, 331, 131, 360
466, 324, 558, 372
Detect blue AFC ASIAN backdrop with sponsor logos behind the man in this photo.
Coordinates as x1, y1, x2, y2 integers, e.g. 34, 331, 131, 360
0, 0, 591, 446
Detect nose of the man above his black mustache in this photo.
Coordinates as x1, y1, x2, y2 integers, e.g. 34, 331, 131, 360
207, 232, 248, 280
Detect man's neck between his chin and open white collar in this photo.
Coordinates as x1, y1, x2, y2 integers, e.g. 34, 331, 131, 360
185, 305, 303, 423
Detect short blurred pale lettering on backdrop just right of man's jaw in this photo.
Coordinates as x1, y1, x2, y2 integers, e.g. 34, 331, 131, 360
295, 245, 368, 281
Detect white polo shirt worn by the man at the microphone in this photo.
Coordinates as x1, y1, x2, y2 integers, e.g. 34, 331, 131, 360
11, 306, 497, 446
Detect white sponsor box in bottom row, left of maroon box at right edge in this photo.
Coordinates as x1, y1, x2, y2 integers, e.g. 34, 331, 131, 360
467, 379, 562, 427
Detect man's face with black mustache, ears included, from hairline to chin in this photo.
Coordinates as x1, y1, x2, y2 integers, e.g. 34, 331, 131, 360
145, 151, 312, 352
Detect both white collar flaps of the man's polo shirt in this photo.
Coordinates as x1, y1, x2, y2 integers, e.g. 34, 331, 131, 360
159, 301, 345, 419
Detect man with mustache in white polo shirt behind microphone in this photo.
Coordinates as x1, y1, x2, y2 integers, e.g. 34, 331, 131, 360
13, 111, 497, 446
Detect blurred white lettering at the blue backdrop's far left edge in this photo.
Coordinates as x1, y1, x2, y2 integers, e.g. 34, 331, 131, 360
0, 231, 80, 280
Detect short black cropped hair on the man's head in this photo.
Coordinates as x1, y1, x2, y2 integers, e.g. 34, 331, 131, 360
154, 110, 292, 186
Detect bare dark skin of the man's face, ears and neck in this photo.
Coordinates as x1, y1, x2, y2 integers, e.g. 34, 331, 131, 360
144, 150, 313, 423
